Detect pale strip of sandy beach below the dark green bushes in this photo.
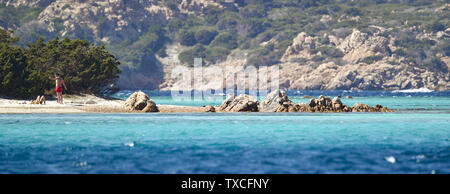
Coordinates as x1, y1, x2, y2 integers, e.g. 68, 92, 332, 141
0, 95, 204, 114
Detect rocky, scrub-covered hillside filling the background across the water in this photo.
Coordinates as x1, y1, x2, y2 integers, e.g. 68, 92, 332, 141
0, 0, 450, 90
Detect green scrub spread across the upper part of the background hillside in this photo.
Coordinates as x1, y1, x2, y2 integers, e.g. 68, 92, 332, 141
4, 0, 450, 69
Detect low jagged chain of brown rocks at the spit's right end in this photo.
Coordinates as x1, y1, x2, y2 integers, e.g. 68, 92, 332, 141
299, 95, 393, 112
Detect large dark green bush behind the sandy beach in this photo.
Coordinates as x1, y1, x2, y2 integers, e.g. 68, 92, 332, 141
0, 29, 120, 97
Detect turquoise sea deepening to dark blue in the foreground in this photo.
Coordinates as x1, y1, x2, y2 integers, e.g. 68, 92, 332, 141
0, 91, 450, 174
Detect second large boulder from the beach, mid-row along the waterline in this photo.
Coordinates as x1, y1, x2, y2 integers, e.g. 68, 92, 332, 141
218, 94, 259, 112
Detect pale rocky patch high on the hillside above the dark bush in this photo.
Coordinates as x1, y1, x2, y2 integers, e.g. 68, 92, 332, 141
38, 0, 172, 43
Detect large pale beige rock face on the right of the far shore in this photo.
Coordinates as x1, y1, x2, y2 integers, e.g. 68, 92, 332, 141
281, 30, 450, 90
